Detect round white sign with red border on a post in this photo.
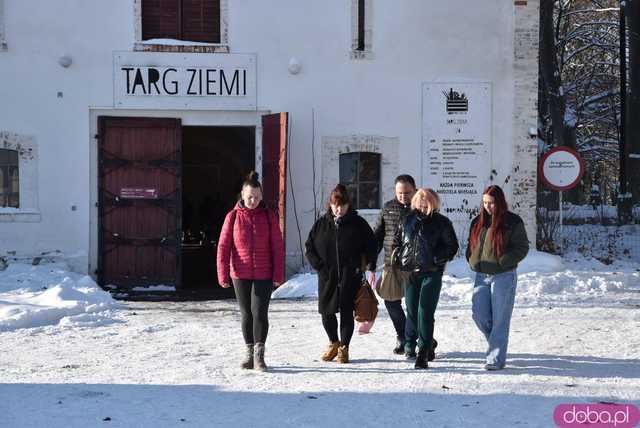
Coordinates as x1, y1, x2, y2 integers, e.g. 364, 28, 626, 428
539, 147, 584, 192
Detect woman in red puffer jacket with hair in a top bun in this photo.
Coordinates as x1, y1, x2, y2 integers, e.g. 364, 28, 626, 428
217, 172, 284, 371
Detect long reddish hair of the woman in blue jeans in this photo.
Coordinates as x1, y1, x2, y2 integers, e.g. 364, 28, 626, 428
469, 185, 508, 257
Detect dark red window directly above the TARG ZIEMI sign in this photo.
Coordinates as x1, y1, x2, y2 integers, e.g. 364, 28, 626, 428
142, 0, 220, 43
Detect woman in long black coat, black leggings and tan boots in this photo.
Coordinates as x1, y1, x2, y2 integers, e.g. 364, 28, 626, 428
305, 184, 377, 363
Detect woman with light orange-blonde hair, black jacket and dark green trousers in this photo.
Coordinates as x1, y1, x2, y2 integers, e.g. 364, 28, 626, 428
393, 188, 458, 369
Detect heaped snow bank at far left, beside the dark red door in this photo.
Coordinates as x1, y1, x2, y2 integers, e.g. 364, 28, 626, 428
0, 263, 120, 331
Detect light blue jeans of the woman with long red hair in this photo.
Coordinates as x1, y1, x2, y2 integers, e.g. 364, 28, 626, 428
472, 269, 518, 367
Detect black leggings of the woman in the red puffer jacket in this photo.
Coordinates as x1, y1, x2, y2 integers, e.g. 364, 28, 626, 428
232, 279, 273, 344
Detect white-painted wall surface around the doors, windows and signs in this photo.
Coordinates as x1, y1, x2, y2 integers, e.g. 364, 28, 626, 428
0, 0, 535, 269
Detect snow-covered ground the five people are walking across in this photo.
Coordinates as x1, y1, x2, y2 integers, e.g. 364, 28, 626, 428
0, 253, 640, 427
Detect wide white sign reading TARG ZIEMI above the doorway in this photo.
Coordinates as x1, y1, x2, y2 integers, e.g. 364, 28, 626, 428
113, 52, 257, 110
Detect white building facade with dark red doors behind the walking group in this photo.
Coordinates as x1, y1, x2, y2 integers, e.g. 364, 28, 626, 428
0, 0, 539, 290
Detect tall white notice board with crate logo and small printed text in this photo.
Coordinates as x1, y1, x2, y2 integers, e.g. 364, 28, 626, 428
422, 82, 491, 241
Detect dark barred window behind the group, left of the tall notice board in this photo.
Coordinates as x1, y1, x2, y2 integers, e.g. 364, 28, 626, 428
340, 152, 380, 209
